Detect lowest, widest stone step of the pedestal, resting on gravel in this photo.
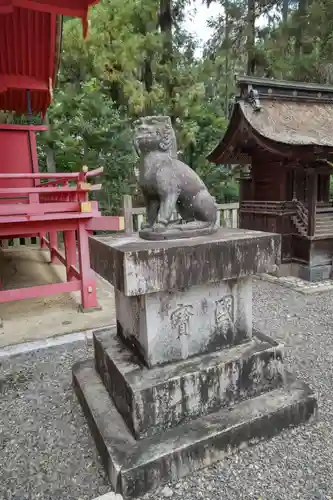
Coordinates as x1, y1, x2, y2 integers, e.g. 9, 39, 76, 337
73, 361, 316, 498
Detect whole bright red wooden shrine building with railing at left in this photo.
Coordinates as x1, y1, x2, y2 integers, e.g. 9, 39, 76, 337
0, 0, 122, 309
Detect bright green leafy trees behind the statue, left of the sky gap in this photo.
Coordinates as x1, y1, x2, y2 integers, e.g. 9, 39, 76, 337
42, 0, 236, 209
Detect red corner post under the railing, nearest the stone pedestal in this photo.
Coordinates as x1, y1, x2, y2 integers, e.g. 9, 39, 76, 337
77, 221, 97, 309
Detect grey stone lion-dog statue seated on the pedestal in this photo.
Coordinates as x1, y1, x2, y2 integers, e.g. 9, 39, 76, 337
134, 116, 217, 239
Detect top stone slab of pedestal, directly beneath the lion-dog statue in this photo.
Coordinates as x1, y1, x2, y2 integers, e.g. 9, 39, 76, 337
90, 228, 281, 296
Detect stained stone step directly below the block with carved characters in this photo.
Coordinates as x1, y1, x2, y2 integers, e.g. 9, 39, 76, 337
94, 329, 284, 439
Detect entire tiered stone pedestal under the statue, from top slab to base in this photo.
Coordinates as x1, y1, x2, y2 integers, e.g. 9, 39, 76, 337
73, 229, 316, 496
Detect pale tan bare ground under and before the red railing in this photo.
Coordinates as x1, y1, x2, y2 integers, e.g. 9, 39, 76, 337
0, 247, 115, 347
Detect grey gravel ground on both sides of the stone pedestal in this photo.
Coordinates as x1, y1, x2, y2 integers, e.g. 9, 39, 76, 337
0, 281, 333, 500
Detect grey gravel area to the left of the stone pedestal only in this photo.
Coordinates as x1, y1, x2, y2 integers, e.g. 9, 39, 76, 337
0, 342, 110, 500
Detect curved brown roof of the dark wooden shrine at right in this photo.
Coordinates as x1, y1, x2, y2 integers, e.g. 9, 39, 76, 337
207, 77, 333, 164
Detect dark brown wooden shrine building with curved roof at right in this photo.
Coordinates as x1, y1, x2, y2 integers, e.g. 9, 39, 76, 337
208, 77, 333, 281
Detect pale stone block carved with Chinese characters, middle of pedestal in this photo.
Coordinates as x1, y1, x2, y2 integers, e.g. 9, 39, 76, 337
115, 277, 252, 367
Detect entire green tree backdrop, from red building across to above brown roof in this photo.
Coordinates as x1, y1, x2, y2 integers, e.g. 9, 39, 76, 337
40, 0, 333, 213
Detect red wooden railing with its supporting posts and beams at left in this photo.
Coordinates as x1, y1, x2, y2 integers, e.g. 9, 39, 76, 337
0, 168, 123, 309
